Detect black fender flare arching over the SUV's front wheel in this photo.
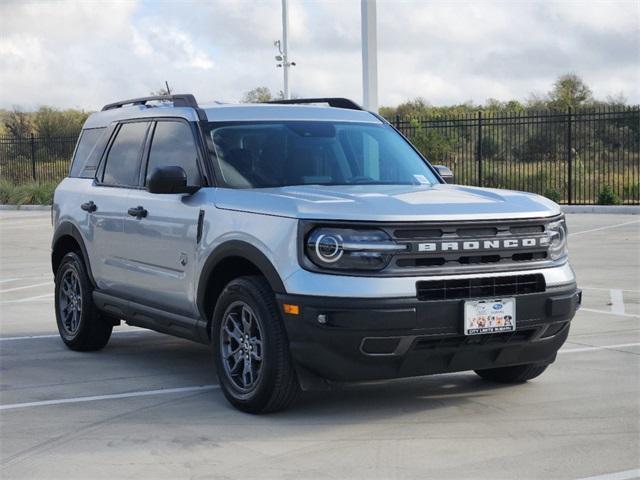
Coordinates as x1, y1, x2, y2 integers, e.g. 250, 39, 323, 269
196, 240, 286, 318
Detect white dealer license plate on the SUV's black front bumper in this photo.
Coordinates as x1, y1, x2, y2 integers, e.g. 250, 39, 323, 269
464, 298, 516, 335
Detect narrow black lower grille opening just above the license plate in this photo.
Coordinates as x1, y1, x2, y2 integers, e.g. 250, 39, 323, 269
416, 273, 545, 300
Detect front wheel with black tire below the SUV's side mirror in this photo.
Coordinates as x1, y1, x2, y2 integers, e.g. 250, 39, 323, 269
211, 276, 300, 413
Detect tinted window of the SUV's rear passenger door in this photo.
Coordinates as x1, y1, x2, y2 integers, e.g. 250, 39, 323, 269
102, 122, 148, 186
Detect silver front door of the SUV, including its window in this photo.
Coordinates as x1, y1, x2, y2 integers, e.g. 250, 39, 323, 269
124, 119, 205, 318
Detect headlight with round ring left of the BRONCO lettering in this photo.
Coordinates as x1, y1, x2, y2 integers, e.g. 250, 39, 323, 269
305, 228, 407, 270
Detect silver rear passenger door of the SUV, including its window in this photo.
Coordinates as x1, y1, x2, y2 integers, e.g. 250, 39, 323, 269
88, 121, 150, 297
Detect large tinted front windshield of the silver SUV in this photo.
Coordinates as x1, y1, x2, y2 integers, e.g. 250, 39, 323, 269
209, 122, 438, 188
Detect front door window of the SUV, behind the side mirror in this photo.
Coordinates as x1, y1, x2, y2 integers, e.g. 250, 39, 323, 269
145, 121, 202, 186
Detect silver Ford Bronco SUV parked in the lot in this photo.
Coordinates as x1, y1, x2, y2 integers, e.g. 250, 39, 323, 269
52, 95, 581, 413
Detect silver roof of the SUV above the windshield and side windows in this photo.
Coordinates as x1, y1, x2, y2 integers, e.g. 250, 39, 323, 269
84, 103, 381, 128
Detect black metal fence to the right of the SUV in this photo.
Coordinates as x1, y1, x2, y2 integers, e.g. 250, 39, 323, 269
391, 107, 640, 205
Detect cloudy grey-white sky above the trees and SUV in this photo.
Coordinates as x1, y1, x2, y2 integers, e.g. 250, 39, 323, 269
0, 0, 640, 109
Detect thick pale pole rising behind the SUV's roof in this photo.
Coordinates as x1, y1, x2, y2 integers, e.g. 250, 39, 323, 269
360, 0, 378, 112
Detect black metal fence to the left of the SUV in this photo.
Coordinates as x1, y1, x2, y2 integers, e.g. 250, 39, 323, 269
0, 135, 78, 184
